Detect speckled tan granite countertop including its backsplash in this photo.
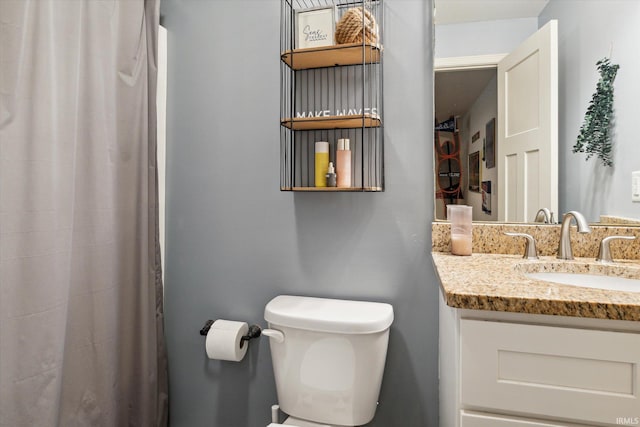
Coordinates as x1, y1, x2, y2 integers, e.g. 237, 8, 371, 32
432, 222, 640, 321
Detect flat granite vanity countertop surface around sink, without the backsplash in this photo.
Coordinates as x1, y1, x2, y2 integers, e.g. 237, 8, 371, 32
431, 252, 640, 321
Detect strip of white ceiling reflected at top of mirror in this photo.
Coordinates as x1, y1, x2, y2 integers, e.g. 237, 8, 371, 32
434, 0, 549, 25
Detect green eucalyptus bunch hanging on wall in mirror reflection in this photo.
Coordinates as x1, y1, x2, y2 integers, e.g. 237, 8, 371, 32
573, 58, 620, 167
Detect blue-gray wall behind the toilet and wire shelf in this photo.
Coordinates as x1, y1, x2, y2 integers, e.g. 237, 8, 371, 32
162, 0, 438, 427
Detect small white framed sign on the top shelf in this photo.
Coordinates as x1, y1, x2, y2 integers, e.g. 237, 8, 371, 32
295, 6, 336, 49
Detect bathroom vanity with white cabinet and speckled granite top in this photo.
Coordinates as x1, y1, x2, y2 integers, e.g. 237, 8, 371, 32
432, 226, 640, 427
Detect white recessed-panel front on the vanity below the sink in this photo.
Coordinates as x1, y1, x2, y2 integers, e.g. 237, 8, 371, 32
460, 319, 640, 425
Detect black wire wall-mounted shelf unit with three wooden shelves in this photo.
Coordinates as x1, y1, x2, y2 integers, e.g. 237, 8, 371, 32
280, 0, 384, 192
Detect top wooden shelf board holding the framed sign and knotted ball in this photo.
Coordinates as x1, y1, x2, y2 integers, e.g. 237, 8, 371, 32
280, 43, 382, 70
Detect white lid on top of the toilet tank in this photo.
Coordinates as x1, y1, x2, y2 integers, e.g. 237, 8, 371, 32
264, 295, 393, 334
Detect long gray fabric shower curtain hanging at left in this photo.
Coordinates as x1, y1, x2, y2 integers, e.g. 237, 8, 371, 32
0, 0, 167, 427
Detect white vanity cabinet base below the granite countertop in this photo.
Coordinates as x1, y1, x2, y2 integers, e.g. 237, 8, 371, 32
440, 290, 640, 427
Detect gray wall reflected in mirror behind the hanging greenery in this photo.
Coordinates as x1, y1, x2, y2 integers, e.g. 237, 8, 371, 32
540, 0, 640, 221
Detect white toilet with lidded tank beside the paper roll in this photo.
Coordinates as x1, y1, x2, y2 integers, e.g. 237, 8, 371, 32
262, 295, 393, 427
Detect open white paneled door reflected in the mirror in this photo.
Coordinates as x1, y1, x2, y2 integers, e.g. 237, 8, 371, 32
496, 20, 558, 222
